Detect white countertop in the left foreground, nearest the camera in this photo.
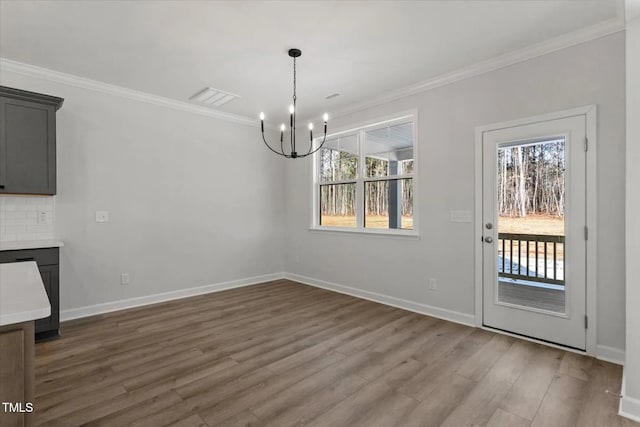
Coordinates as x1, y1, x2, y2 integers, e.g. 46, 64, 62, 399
0, 261, 51, 326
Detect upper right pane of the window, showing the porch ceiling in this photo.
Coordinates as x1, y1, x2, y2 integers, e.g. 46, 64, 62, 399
364, 122, 413, 177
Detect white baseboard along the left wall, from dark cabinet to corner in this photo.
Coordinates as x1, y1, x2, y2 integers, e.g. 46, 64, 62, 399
60, 273, 285, 322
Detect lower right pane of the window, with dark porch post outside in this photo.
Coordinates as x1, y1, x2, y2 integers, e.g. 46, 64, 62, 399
364, 178, 413, 230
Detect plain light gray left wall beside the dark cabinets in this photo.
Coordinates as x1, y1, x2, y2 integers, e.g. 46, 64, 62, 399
2, 70, 284, 311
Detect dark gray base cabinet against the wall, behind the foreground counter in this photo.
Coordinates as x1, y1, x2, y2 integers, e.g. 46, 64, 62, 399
0, 248, 60, 339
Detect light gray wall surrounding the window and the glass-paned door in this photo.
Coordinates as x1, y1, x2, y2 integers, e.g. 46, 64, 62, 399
286, 33, 625, 349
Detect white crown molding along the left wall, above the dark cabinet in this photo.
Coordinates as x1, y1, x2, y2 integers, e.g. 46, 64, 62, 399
0, 57, 258, 127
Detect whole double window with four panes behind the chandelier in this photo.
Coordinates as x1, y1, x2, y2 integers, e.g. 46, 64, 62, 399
314, 115, 416, 234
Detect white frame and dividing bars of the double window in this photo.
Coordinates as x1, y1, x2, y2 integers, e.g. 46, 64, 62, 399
310, 110, 419, 238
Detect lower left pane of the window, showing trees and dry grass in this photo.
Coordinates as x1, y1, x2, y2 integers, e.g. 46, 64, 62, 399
320, 183, 356, 227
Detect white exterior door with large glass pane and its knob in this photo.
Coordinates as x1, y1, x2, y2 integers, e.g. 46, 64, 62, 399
482, 115, 587, 350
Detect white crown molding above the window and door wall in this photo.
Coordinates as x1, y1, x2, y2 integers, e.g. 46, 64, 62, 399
332, 16, 625, 118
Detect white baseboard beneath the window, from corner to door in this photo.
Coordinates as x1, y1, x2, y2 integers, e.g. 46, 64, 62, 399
285, 273, 475, 327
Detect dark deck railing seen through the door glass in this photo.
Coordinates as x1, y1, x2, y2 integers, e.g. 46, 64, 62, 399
498, 233, 564, 286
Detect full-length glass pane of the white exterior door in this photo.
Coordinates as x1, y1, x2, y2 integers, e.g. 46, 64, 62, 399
497, 138, 566, 313
